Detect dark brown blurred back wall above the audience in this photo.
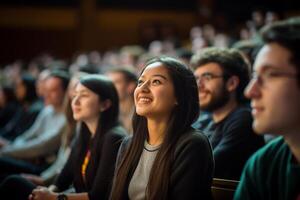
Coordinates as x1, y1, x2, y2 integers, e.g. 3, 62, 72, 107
0, 0, 300, 68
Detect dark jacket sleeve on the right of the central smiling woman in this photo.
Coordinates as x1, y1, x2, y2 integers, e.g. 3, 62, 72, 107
170, 133, 214, 199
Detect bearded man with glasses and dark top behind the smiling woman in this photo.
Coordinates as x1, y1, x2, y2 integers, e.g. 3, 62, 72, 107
191, 48, 264, 180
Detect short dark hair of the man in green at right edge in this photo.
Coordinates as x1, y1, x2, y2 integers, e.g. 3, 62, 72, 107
260, 17, 300, 82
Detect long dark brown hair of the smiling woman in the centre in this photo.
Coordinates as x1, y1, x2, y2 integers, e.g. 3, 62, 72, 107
111, 57, 199, 200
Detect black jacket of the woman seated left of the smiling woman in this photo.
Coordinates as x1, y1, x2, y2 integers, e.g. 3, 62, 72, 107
55, 126, 126, 200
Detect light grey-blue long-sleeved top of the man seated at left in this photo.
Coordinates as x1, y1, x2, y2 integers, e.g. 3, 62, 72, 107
0, 105, 66, 159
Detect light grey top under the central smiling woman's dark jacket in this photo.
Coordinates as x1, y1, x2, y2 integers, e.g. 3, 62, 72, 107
128, 141, 160, 200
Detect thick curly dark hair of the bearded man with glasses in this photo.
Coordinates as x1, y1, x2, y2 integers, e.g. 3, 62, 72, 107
190, 47, 250, 103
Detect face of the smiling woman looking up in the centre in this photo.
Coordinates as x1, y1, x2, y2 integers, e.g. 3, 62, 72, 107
134, 62, 177, 121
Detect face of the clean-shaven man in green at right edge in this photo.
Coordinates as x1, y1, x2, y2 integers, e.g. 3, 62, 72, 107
245, 43, 300, 134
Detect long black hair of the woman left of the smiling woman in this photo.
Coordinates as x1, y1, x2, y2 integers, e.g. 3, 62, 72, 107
76, 74, 119, 187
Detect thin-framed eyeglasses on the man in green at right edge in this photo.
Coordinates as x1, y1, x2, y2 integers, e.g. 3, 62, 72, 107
251, 71, 298, 86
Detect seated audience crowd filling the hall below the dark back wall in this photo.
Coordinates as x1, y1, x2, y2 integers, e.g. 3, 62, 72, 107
0, 13, 300, 200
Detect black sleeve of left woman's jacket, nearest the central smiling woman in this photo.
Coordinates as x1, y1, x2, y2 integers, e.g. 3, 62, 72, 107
88, 128, 125, 200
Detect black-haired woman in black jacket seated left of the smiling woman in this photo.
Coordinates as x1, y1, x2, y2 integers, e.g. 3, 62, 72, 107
0, 75, 127, 200
